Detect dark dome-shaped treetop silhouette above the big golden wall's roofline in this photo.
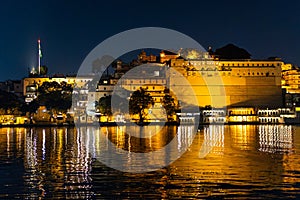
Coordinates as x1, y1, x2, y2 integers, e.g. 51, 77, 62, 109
215, 44, 251, 60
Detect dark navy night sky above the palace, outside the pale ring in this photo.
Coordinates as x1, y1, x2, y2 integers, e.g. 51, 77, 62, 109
0, 0, 300, 81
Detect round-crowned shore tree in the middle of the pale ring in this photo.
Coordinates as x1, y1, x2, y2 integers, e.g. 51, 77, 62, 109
129, 88, 154, 123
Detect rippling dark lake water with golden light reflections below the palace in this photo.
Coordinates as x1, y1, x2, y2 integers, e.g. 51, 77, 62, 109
0, 125, 300, 199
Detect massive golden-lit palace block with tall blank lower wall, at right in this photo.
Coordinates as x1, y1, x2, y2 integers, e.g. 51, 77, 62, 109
170, 51, 285, 108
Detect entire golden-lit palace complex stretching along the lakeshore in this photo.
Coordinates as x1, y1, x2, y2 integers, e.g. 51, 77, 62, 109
23, 50, 300, 122
